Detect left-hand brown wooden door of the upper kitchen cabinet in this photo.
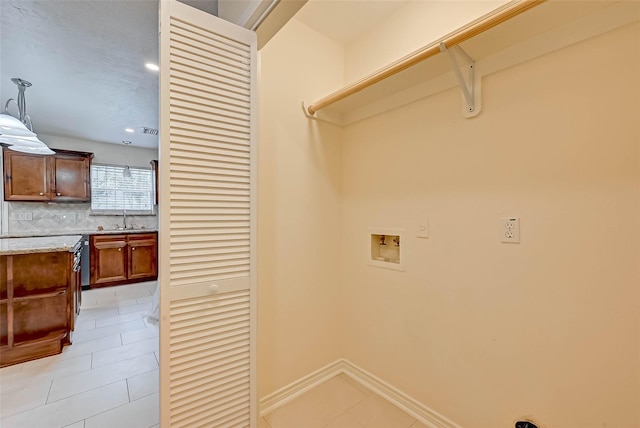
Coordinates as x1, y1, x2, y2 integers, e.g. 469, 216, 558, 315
4, 150, 49, 201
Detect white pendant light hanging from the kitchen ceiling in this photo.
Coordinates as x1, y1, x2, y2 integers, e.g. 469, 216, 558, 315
0, 77, 55, 155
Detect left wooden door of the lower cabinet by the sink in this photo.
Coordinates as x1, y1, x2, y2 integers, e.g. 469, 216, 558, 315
91, 235, 127, 285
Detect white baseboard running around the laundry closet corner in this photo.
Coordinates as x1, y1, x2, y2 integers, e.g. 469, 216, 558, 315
260, 358, 461, 428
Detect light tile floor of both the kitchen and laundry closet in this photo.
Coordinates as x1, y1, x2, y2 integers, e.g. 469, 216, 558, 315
0, 281, 426, 428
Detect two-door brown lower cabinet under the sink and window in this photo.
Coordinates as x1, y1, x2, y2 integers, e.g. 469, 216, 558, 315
90, 232, 158, 287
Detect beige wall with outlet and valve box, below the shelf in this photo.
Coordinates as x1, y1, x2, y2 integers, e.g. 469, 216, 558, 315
344, 21, 640, 428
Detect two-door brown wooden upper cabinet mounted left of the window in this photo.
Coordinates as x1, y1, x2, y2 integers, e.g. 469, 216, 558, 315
3, 148, 93, 202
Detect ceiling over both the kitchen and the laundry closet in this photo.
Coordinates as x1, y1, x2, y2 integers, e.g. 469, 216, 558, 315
0, 0, 407, 148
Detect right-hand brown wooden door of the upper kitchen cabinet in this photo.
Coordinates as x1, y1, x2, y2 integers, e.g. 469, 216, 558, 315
52, 155, 91, 202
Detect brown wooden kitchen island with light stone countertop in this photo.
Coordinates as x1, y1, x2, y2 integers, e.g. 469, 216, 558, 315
0, 235, 82, 367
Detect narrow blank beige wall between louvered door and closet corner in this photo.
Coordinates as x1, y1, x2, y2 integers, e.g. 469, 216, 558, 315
258, 16, 342, 398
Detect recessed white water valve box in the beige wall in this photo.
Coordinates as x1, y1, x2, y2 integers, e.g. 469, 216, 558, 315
367, 229, 406, 271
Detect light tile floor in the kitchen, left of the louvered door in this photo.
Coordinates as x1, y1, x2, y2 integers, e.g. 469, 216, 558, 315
0, 281, 159, 428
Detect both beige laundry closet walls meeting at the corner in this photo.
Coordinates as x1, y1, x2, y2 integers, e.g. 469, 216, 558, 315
258, 2, 640, 428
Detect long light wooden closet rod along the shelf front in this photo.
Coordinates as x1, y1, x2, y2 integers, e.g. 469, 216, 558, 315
307, 0, 546, 115
